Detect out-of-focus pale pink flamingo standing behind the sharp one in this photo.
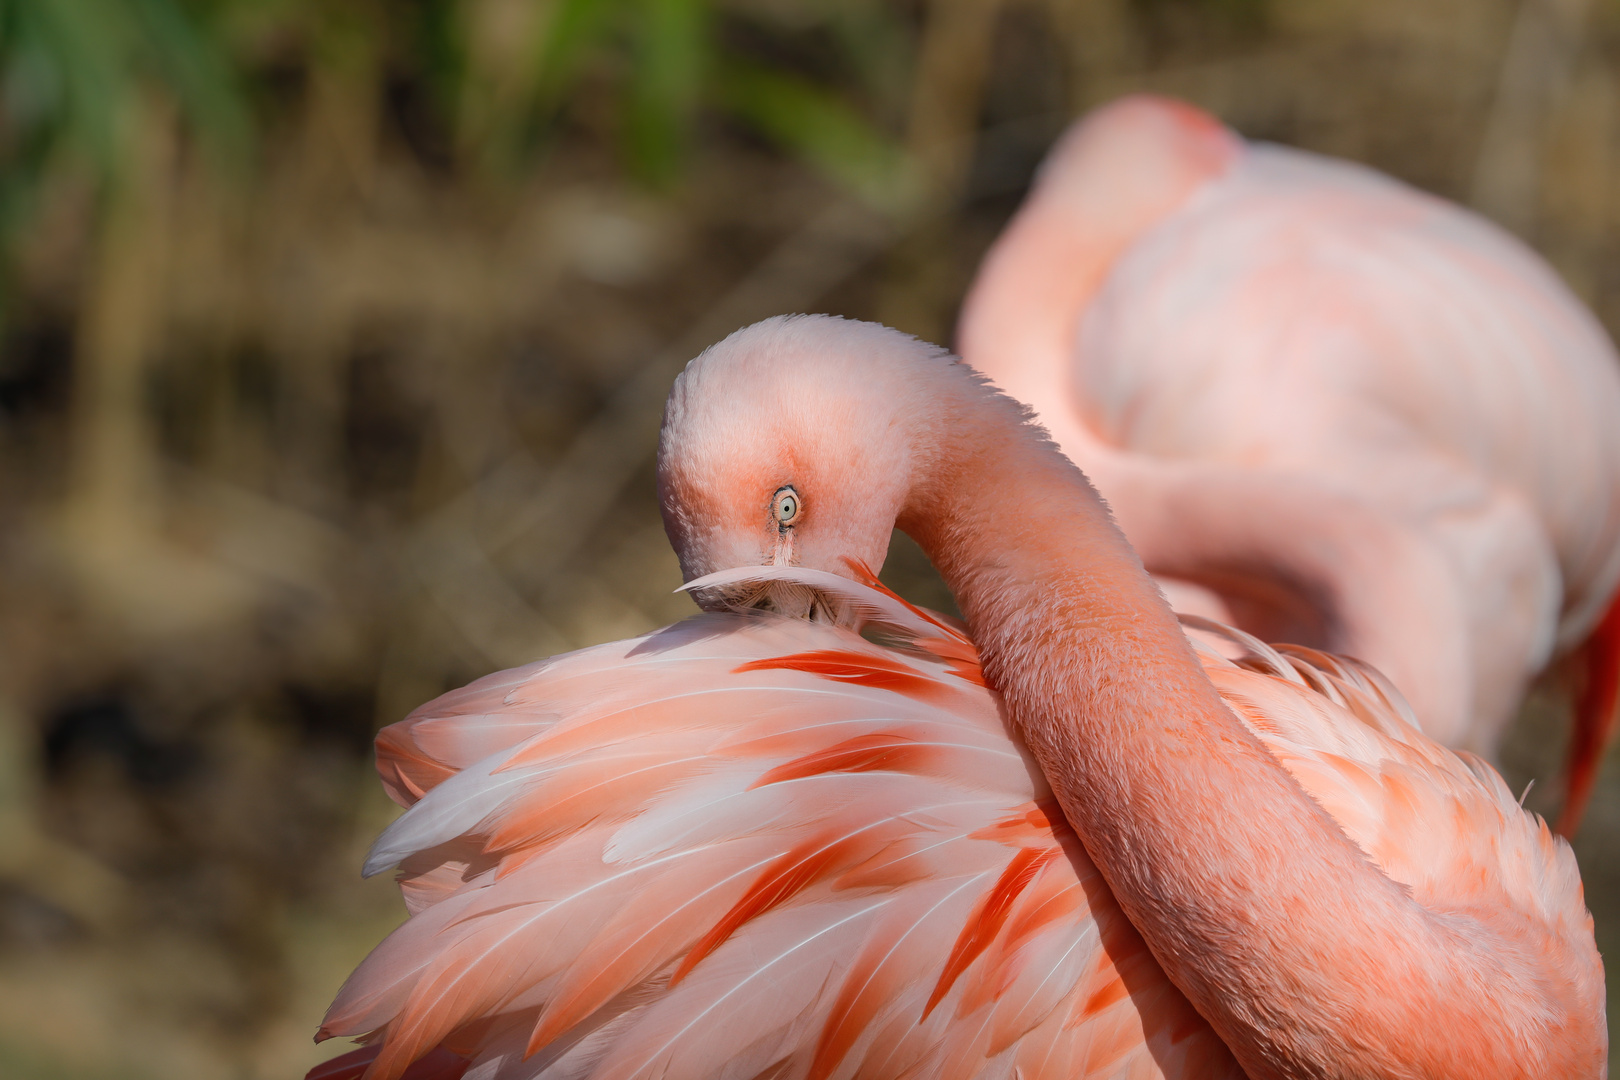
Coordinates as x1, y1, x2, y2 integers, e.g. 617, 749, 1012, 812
957, 96, 1620, 834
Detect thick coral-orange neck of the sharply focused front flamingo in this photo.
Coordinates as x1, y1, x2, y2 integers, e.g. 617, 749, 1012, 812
899, 377, 1574, 1077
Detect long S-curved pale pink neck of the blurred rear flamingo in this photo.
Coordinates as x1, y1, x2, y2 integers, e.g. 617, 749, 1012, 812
957, 110, 1483, 745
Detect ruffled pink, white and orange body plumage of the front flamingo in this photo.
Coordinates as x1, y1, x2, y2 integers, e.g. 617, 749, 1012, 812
313, 568, 1584, 1080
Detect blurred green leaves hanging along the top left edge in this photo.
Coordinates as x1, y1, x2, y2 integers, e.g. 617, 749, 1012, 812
0, 0, 910, 220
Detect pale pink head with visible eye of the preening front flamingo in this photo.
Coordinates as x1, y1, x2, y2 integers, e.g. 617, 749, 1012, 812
658, 316, 966, 606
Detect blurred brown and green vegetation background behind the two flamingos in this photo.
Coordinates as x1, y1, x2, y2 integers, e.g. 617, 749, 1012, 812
0, 0, 1620, 1080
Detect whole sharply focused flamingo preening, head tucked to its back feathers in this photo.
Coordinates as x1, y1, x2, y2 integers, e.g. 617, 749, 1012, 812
309, 316, 1607, 1080
